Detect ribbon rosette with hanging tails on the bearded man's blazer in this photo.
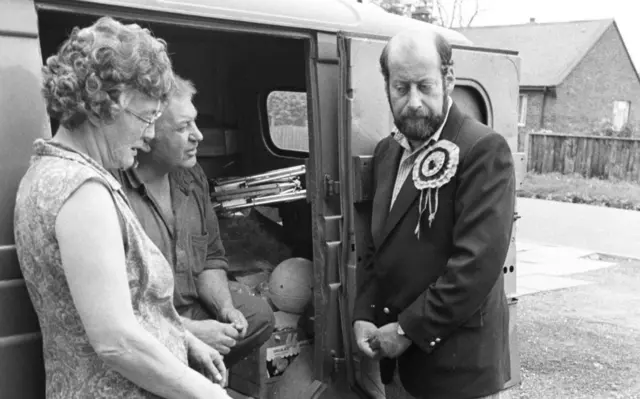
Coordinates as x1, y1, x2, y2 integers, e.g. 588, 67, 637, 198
413, 140, 460, 238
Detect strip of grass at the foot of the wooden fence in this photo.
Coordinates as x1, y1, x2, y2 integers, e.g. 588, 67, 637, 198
518, 173, 640, 211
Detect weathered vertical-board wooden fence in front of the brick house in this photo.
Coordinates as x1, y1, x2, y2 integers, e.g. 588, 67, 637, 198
524, 133, 640, 182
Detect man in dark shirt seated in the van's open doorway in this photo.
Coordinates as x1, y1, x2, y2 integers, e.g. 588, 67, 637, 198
114, 78, 275, 367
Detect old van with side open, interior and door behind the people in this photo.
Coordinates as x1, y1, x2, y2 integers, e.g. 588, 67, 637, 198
0, 0, 523, 399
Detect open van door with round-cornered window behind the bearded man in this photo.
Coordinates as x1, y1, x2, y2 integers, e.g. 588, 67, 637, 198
338, 33, 520, 399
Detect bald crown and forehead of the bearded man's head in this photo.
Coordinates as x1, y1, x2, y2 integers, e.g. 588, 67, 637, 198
380, 29, 453, 83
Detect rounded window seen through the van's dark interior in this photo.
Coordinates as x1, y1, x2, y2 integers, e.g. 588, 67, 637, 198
267, 91, 309, 152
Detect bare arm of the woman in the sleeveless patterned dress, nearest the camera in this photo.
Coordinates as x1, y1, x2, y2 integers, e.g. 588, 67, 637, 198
55, 182, 228, 399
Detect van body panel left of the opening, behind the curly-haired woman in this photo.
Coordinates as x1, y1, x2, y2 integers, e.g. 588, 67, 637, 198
0, 0, 51, 399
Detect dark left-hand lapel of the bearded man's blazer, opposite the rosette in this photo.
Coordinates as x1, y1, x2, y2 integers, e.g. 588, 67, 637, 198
371, 140, 402, 244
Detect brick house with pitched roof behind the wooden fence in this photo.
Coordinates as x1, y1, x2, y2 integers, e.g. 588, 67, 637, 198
460, 19, 640, 139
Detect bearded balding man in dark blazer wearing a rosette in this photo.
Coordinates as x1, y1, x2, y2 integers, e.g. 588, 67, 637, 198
353, 31, 515, 399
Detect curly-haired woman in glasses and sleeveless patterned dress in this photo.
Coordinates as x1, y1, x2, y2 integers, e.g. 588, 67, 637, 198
15, 18, 228, 399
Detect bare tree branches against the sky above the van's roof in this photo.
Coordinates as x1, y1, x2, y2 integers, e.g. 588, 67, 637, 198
370, 0, 482, 28
